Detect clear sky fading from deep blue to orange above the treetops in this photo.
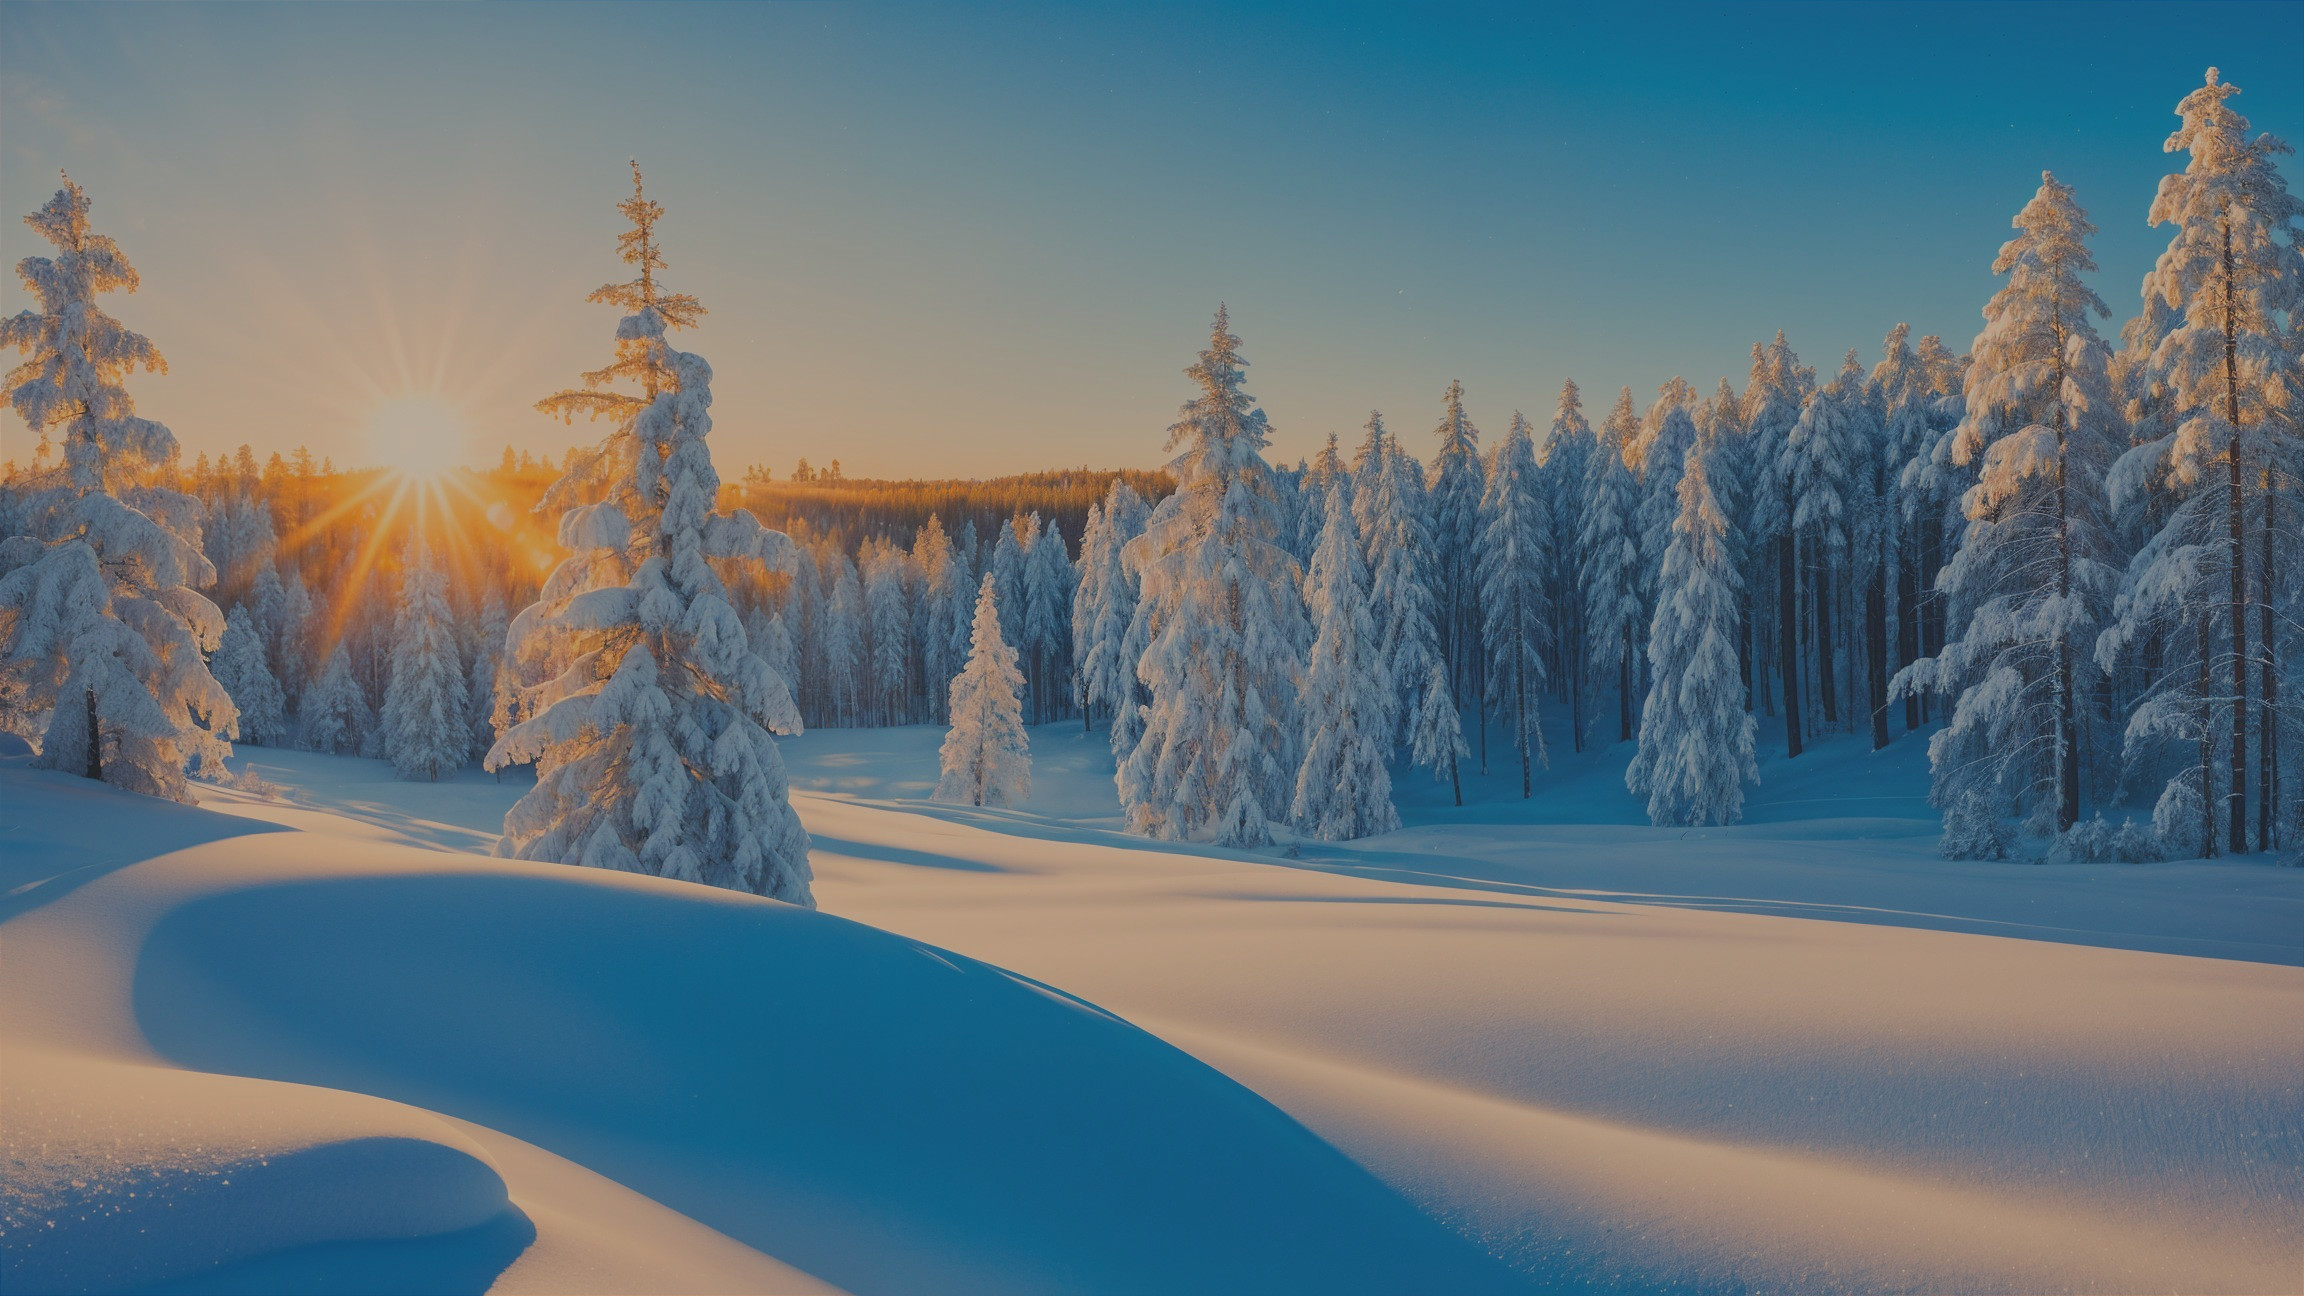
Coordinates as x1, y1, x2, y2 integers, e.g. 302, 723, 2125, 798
0, 2, 2304, 477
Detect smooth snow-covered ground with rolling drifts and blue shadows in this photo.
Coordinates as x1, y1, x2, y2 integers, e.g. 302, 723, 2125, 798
0, 726, 2304, 1294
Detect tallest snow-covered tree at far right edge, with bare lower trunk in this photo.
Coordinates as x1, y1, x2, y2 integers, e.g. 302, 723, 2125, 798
2117, 67, 2304, 853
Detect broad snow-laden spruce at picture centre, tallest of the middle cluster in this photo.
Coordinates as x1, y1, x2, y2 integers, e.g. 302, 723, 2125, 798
1117, 307, 1304, 846
